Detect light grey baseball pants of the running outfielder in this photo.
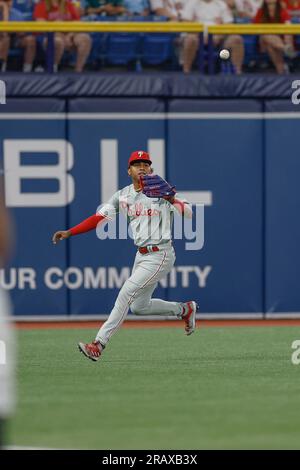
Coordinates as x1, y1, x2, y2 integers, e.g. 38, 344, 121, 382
96, 246, 181, 345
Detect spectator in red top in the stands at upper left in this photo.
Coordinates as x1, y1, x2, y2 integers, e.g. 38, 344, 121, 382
33, 0, 92, 72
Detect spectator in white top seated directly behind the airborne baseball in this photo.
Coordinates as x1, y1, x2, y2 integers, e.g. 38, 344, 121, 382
182, 0, 244, 74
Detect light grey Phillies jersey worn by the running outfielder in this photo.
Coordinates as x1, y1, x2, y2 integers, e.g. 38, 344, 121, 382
97, 184, 187, 247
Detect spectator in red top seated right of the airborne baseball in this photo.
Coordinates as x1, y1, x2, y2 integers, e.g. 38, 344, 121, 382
254, 0, 297, 74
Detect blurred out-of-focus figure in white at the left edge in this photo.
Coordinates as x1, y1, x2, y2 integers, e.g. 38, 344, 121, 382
0, 179, 15, 449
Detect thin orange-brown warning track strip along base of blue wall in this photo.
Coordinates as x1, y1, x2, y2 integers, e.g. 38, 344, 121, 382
15, 318, 300, 330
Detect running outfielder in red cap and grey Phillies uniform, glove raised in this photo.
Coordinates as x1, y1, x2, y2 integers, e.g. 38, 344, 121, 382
52, 151, 198, 361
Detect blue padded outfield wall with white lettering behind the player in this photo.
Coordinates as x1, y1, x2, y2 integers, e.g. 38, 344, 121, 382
0, 75, 300, 316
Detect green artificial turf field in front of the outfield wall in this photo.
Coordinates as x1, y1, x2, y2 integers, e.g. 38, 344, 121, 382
10, 327, 300, 450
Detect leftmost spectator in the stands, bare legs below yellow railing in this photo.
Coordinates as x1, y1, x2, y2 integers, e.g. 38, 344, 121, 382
0, 0, 36, 72
